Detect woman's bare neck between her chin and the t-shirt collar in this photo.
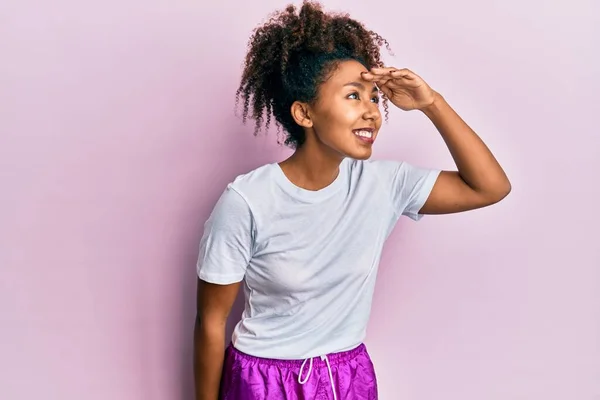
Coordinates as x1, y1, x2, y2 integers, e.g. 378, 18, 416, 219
279, 134, 344, 190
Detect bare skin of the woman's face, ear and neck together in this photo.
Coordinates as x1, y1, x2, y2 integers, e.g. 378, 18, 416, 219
279, 61, 381, 190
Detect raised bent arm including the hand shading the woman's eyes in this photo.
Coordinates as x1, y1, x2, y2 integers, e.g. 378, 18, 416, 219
362, 68, 511, 214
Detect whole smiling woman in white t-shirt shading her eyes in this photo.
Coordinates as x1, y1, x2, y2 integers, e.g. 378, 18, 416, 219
194, 2, 510, 400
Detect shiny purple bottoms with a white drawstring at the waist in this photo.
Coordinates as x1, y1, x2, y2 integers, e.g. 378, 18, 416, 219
221, 344, 377, 400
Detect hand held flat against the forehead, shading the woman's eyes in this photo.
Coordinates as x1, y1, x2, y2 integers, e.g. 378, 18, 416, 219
362, 68, 437, 111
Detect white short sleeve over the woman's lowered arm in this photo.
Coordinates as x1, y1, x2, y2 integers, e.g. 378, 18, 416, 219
196, 185, 254, 285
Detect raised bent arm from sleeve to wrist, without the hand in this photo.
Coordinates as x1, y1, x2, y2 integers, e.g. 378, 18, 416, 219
420, 93, 511, 214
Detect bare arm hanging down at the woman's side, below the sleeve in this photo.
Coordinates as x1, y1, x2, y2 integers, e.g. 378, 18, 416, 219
194, 279, 240, 400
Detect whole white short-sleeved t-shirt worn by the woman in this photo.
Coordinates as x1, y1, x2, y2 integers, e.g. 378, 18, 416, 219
197, 158, 439, 359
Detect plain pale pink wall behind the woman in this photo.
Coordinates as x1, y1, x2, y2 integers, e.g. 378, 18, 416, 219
0, 0, 600, 400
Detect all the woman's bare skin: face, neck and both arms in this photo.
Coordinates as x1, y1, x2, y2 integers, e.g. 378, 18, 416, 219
194, 57, 511, 400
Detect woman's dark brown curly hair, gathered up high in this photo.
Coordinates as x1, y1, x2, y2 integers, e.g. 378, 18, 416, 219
236, 0, 391, 148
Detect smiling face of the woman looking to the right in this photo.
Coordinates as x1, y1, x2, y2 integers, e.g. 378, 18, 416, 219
298, 60, 381, 160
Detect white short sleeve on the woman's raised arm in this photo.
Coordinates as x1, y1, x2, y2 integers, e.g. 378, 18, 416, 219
373, 161, 440, 221
